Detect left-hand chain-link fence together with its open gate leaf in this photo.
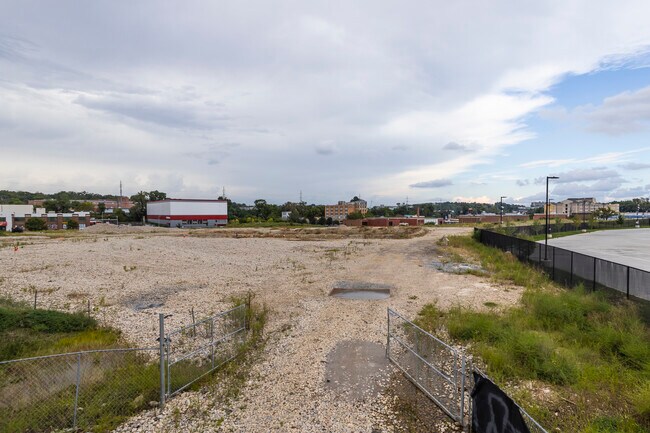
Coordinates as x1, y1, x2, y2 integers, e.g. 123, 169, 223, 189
0, 304, 250, 433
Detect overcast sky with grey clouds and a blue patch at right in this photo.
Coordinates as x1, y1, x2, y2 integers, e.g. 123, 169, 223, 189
0, 0, 650, 205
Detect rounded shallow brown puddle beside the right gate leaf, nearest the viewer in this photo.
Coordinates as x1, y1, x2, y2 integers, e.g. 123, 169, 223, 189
325, 340, 389, 401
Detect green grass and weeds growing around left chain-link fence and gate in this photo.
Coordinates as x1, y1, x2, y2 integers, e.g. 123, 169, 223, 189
0, 297, 266, 432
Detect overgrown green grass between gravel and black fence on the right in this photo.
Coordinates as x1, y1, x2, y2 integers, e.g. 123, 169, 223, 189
418, 237, 650, 433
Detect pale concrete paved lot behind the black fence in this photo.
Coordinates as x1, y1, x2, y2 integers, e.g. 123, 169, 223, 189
542, 229, 650, 272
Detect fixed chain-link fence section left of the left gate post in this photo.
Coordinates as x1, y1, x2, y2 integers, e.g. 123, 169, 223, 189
0, 348, 159, 432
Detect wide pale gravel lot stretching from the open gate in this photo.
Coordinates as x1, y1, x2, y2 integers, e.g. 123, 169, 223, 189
0, 228, 521, 432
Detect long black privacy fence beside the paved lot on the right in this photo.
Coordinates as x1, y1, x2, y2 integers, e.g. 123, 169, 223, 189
474, 228, 650, 301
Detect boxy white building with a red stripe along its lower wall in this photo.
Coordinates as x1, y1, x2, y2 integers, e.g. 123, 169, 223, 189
147, 198, 228, 227
